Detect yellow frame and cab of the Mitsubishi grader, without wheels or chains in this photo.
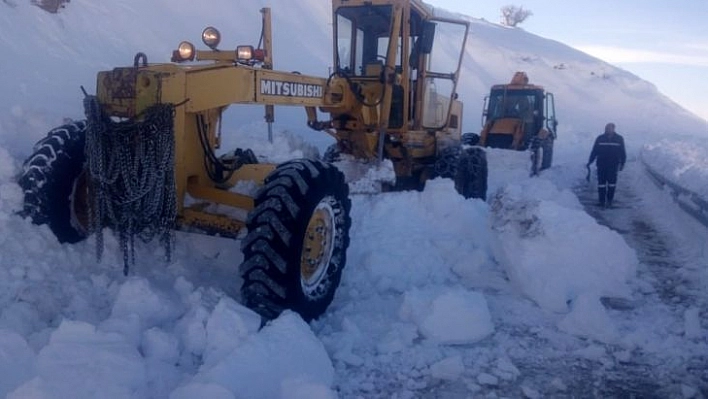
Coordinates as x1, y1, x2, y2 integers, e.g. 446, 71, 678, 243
92, 0, 469, 235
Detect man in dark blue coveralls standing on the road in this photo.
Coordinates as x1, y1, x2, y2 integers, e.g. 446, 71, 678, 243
588, 123, 627, 208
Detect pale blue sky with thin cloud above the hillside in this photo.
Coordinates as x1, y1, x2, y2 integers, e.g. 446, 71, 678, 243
425, 0, 708, 123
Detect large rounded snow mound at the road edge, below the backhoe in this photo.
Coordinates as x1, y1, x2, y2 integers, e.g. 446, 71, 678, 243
491, 179, 638, 312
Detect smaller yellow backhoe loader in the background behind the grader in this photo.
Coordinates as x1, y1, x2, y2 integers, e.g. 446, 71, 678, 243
470, 72, 558, 175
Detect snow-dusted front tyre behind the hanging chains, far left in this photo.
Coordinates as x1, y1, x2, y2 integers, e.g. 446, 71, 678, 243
18, 121, 88, 243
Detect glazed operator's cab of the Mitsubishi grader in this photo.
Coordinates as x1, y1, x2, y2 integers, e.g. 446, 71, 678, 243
333, 0, 468, 133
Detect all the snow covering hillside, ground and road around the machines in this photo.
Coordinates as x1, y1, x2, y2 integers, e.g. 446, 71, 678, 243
0, 0, 708, 398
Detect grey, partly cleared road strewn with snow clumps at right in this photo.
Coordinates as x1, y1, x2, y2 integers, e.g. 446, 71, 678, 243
392, 162, 708, 398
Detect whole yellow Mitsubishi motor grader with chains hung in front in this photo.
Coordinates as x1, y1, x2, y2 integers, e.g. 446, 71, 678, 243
18, 0, 487, 320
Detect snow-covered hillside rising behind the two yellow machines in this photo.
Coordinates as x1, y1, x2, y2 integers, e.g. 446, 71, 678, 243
0, 0, 708, 160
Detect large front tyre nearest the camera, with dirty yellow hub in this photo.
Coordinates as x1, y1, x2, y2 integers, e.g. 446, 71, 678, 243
240, 159, 351, 322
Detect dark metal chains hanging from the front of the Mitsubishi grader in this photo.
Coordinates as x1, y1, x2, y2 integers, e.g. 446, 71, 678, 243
84, 96, 177, 275
